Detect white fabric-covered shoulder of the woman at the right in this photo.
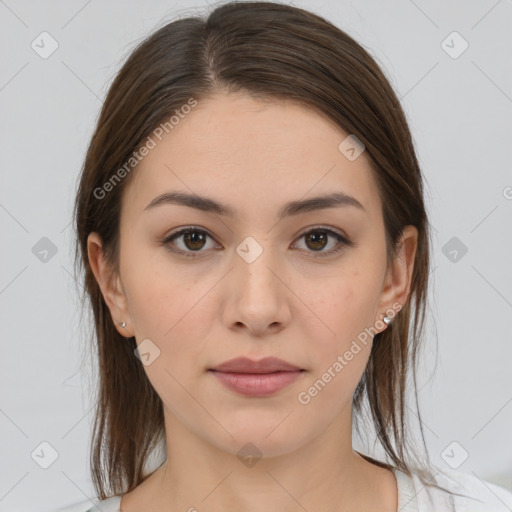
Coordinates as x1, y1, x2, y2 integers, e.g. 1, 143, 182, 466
412, 466, 512, 512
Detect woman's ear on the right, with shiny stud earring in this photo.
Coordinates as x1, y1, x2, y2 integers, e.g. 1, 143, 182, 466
375, 225, 418, 332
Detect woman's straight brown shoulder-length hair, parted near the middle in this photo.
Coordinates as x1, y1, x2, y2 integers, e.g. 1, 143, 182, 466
74, 2, 458, 499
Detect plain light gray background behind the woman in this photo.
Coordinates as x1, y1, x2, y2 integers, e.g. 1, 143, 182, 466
0, 0, 512, 512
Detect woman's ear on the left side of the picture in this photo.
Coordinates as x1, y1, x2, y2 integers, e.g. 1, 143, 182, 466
87, 232, 134, 338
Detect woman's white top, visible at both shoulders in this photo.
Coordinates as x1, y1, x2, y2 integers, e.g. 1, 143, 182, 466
59, 469, 512, 512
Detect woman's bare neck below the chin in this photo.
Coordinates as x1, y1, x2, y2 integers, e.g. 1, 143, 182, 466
135, 410, 398, 512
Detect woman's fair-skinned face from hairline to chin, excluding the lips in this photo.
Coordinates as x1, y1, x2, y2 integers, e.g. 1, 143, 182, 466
90, 90, 416, 455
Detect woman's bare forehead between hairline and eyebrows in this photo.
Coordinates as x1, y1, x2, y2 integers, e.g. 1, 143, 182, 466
125, 93, 378, 219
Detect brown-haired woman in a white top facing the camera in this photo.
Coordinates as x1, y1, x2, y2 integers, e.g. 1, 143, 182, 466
66, 2, 512, 512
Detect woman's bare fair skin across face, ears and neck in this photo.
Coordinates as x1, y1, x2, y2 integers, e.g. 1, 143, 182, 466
88, 93, 417, 512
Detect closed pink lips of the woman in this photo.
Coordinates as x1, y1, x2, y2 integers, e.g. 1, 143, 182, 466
209, 357, 305, 397
